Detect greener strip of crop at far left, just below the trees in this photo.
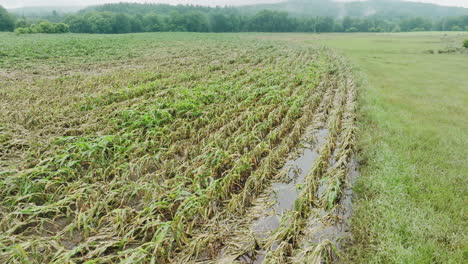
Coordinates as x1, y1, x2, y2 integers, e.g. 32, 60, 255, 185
0, 32, 158, 70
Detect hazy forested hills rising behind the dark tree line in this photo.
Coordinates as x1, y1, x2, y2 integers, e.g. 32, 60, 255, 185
8, 0, 468, 19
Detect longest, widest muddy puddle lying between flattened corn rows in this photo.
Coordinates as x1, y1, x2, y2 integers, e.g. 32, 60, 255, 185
238, 129, 328, 264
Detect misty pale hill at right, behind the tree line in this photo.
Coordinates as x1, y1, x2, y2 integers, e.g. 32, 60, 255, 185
239, 0, 468, 18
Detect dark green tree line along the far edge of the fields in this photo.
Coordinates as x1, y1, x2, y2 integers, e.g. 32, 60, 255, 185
0, 4, 468, 34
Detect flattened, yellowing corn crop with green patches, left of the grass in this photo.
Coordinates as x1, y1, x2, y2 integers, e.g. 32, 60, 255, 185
0, 34, 356, 263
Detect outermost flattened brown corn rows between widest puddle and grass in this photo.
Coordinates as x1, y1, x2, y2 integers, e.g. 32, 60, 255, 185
264, 54, 356, 263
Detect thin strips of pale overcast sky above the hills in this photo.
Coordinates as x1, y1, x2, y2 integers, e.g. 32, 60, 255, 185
0, 0, 468, 8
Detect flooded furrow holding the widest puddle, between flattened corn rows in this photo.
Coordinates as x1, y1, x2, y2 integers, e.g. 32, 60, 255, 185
210, 72, 337, 264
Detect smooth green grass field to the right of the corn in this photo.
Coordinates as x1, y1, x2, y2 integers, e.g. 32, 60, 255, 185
319, 33, 468, 263
